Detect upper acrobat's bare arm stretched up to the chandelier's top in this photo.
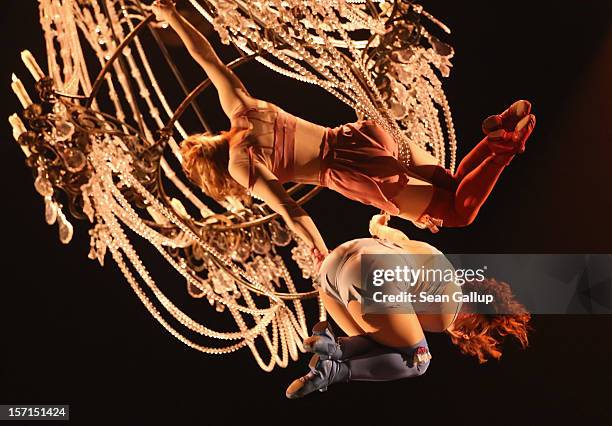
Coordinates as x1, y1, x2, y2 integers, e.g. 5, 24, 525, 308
153, 0, 252, 118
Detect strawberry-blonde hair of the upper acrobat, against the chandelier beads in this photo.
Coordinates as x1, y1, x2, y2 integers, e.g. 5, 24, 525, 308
181, 131, 249, 201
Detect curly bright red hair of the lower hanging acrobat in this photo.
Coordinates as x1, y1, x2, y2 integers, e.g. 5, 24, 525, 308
449, 279, 531, 364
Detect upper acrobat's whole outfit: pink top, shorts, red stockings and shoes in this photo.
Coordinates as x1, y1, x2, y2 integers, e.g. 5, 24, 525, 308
230, 97, 535, 232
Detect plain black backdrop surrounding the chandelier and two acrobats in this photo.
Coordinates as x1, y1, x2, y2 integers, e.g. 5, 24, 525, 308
0, 0, 612, 425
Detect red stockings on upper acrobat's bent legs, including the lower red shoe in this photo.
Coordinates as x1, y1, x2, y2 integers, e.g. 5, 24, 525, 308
424, 116, 535, 227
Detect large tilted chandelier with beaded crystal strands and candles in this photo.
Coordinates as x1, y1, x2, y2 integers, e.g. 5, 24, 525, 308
9, 0, 456, 371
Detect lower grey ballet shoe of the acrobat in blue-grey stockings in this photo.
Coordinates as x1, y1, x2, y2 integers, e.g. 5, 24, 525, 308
285, 354, 349, 399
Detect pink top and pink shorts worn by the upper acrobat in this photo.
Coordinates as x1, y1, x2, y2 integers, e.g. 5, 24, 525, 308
232, 101, 413, 214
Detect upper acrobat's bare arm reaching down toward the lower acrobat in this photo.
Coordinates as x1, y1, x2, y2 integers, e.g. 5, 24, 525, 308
229, 158, 328, 254
